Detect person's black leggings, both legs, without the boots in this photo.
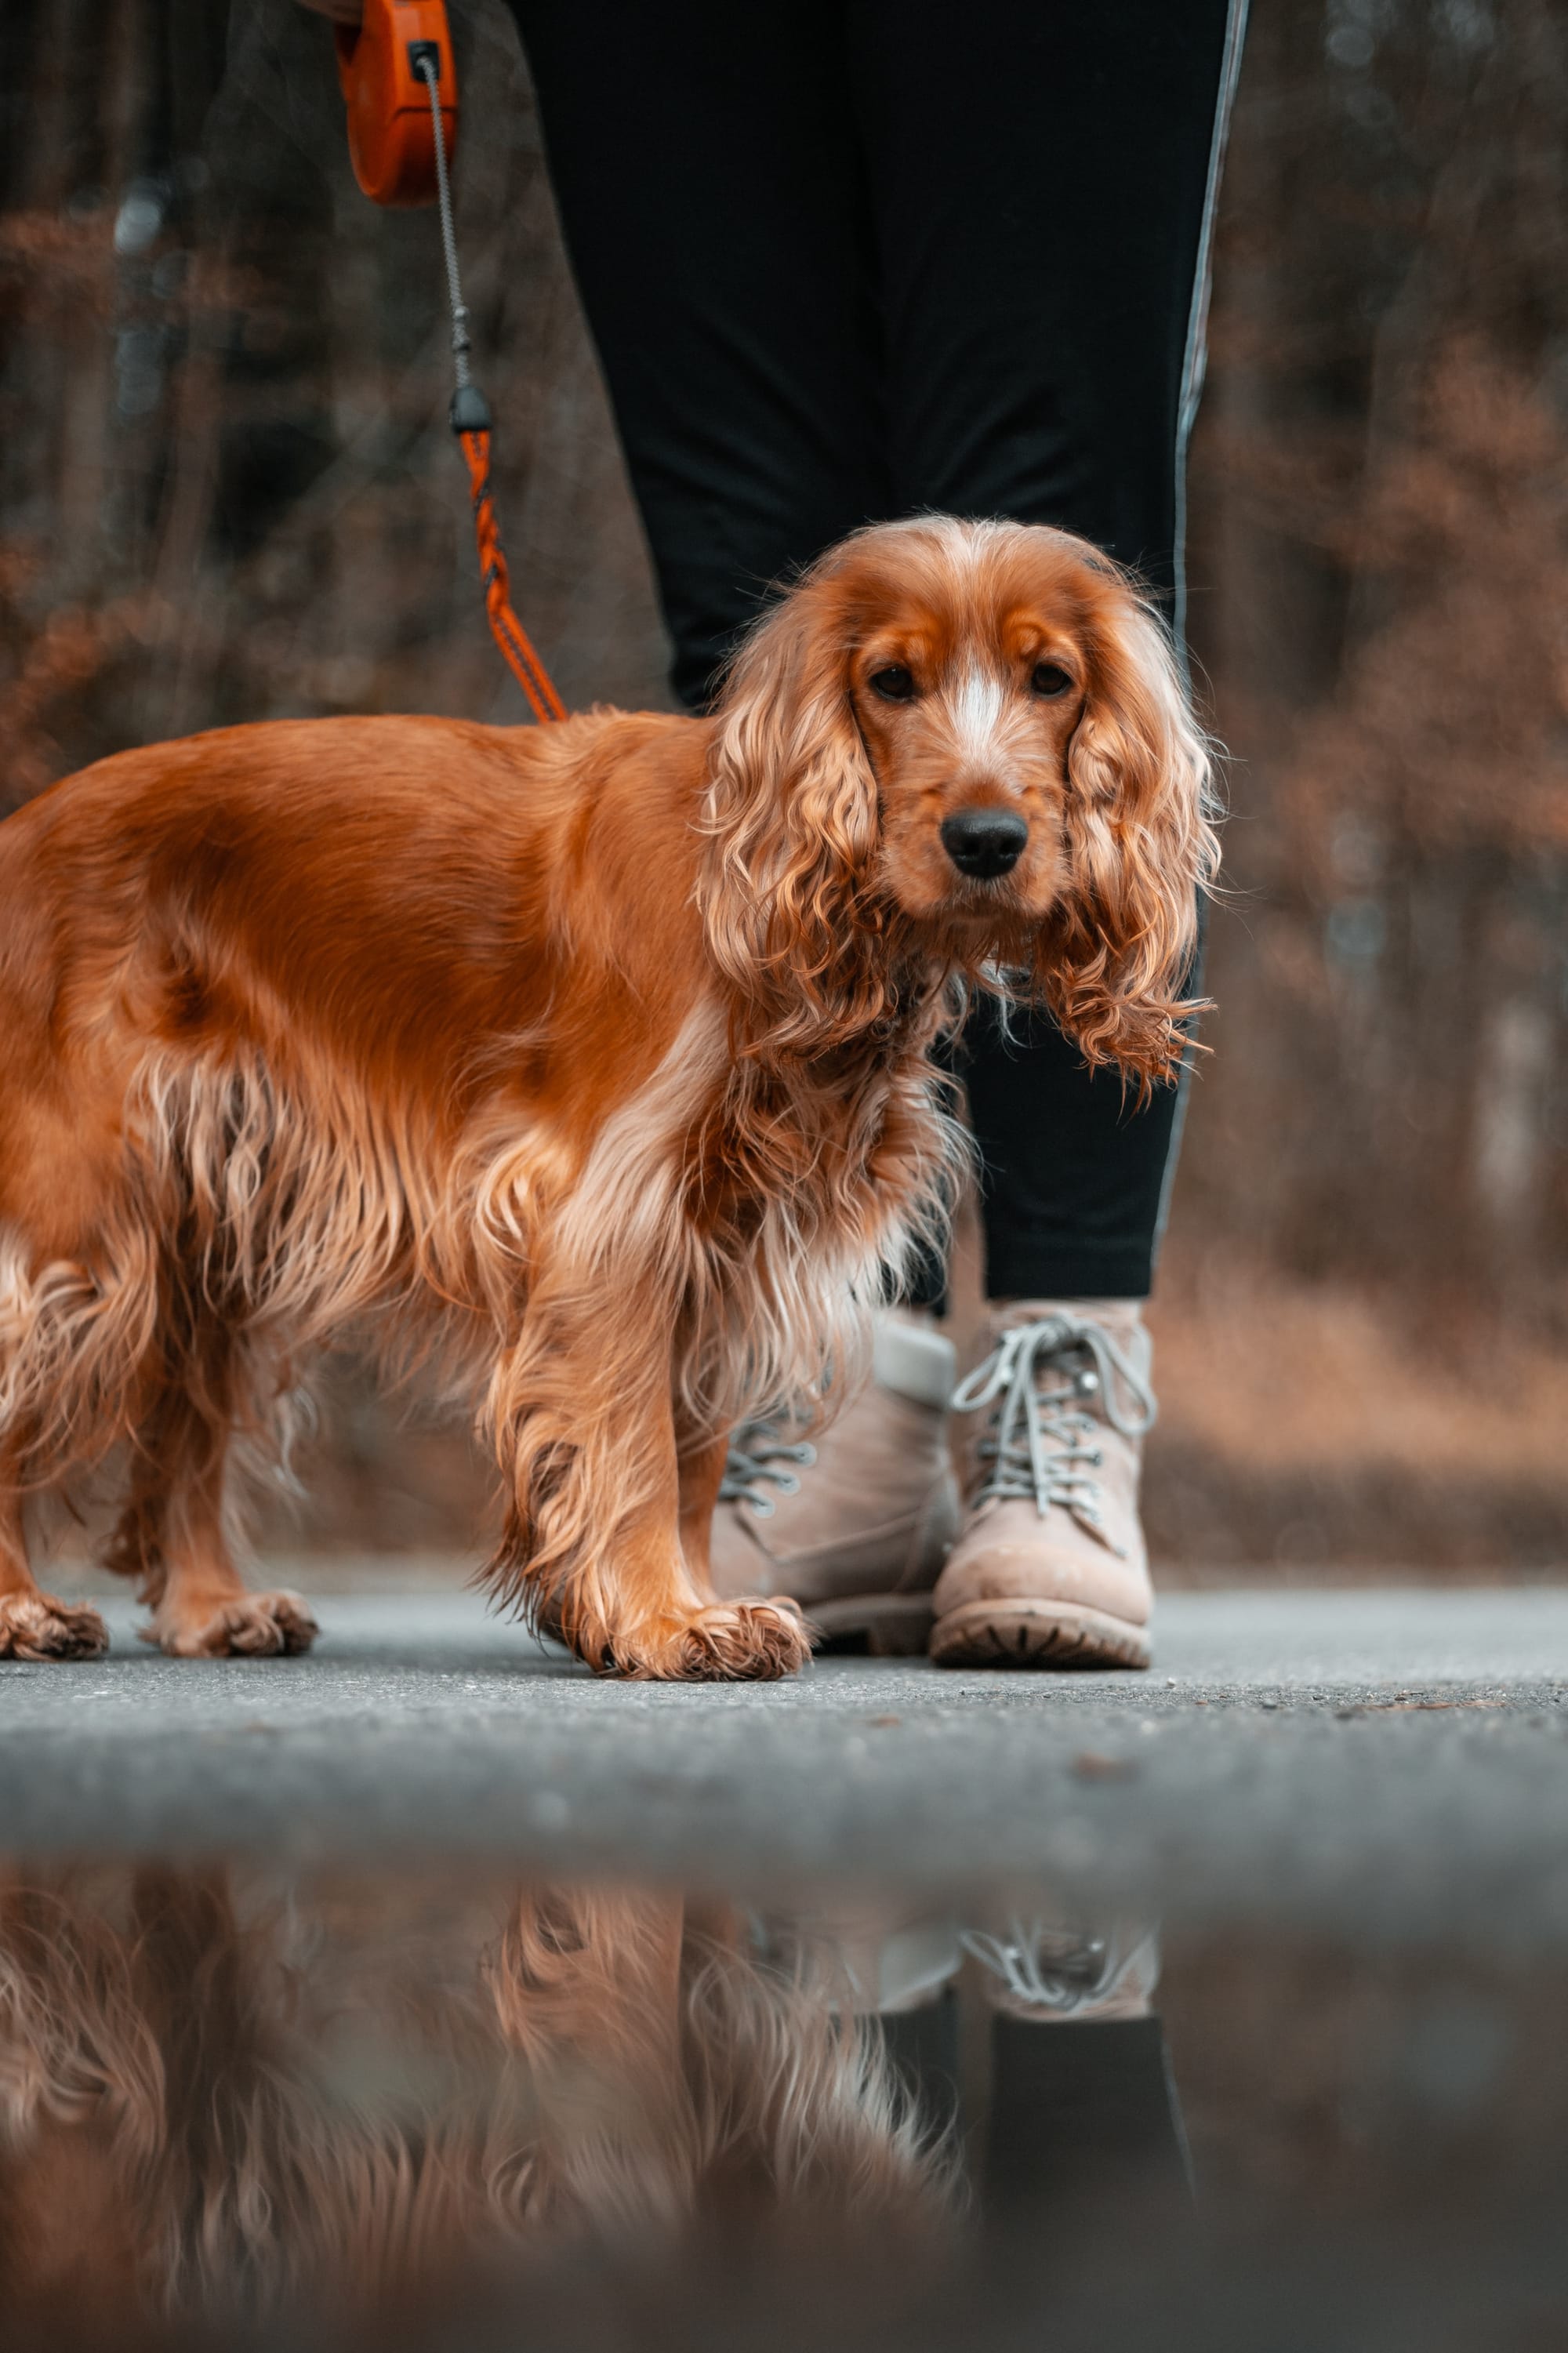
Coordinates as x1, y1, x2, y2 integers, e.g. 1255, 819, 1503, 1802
514, 0, 1243, 1299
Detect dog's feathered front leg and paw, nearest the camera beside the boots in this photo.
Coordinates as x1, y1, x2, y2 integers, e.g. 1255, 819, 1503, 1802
488, 1269, 808, 1683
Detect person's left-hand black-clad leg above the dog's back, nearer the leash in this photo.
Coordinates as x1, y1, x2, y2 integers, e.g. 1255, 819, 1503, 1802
514, 0, 890, 708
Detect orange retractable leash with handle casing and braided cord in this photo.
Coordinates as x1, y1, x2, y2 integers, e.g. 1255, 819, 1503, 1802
336, 0, 568, 722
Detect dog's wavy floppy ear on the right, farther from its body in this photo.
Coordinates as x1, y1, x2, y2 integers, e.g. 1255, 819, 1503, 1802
1036, 597, 1220, 1094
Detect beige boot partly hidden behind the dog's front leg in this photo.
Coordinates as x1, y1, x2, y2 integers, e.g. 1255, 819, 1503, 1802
711, 1313, 958, 1657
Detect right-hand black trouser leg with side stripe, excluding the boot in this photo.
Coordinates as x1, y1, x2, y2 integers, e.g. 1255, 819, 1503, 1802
850, 0, 1243, 1299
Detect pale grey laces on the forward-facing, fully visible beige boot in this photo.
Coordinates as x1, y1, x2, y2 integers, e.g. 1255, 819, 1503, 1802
953, 1316, 1156, 1560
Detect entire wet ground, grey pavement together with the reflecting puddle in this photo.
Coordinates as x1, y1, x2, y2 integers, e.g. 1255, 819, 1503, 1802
0, 1591, 1568, 2353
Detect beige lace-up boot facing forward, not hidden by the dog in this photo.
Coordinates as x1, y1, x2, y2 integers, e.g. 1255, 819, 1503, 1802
930, 1299, 1156, 1669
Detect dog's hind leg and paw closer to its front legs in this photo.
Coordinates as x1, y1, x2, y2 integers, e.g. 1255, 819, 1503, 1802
103, 1327, 315, 1659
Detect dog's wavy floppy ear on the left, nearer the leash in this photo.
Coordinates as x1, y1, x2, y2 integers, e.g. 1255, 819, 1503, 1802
702, 569, 885, 1054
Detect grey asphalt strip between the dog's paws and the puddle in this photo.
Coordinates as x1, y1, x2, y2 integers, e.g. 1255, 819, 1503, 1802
0, 1591, 1568, 1944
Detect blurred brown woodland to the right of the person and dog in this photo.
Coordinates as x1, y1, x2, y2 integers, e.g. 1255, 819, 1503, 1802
1185, 0, 1568, 1342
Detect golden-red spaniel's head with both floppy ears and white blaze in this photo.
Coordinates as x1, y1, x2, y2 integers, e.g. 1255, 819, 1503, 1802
706, 517, 1218, 1082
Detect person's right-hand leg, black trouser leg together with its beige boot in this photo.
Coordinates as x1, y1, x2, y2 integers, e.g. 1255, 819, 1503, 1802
824, 0, 1243, 1669
